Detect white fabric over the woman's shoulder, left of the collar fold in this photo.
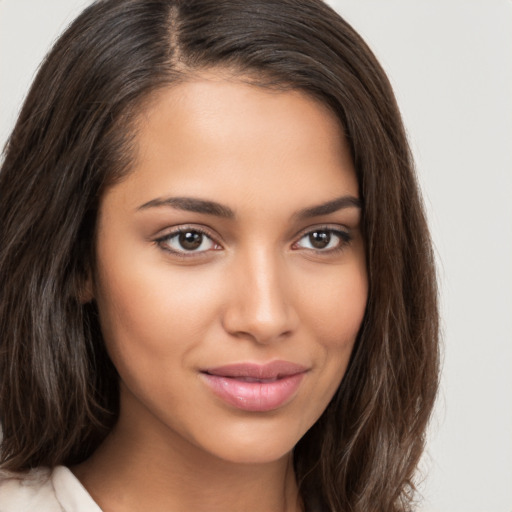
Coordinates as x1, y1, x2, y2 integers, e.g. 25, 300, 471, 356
0, 468, 63, 512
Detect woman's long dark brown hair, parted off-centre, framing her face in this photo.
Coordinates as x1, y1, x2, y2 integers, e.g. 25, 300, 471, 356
0, 0, 439, 512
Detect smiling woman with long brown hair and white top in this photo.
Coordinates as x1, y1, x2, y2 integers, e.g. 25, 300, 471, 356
0, 0, 438, 512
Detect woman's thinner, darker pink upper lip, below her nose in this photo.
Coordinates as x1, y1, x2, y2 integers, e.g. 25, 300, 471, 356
203, 361, 308, 379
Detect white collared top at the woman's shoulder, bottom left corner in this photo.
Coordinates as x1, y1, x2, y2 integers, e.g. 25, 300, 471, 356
0, 466, 101, 512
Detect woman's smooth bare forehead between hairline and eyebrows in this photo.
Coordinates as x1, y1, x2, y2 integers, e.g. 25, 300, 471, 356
106, 76, 358, 217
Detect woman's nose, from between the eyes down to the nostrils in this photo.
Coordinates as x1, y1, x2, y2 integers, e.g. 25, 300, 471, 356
223, 251, 299, 344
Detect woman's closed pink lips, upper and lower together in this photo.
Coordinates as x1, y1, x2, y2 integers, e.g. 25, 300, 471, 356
202, 361, 307, 412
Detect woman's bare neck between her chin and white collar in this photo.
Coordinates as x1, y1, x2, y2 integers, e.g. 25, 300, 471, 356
72, 400, 301, 512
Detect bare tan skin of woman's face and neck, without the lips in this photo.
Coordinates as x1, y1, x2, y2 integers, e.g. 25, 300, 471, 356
73, 75, 367, 512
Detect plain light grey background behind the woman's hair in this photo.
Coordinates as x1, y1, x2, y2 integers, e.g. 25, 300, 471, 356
0, 0, 512, 512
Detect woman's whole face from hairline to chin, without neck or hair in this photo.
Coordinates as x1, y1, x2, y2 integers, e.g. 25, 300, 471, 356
91, 76, 367, 463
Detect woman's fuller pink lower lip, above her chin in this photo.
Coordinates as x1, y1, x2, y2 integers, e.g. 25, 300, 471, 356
203, 373, 305, 412
